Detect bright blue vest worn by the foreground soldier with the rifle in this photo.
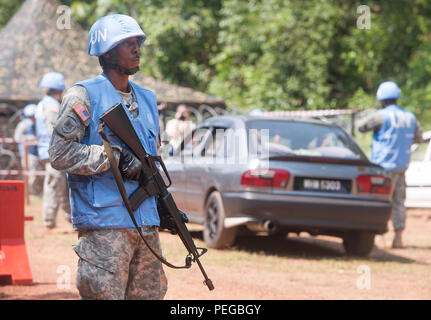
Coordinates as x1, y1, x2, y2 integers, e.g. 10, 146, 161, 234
67, 74, 160, 230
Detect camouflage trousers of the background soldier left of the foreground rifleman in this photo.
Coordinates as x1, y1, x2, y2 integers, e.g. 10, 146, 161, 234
42, 163, 71, 228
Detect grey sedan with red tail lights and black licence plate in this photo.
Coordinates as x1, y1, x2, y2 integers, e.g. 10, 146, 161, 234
165, 116, 392, 256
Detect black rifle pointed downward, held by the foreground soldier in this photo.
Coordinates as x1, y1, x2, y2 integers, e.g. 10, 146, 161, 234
100, 103, 214, 290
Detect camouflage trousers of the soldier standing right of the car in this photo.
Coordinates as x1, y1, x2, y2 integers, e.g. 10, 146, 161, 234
388, 171, 406, 231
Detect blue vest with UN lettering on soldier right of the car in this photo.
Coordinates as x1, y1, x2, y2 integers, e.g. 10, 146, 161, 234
371, 104, 416, 171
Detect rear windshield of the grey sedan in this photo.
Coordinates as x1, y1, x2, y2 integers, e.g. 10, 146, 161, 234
247, 120, 366, 160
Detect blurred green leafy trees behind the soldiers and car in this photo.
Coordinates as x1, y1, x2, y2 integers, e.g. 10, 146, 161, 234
0, 0, 431, 129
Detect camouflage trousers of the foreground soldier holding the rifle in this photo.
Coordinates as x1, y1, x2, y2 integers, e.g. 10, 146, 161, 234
74, 227, 167, 300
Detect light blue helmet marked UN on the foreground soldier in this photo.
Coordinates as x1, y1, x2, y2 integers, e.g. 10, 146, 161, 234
88, 14, 147, 56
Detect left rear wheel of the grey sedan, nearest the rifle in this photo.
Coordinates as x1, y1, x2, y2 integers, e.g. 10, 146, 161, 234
203, 191, 237, 249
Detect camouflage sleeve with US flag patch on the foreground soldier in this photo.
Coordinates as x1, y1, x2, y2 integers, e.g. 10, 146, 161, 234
49, 86, 120, 175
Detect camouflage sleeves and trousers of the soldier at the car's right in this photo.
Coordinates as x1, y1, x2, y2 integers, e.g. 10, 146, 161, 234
358, 113, 422, 231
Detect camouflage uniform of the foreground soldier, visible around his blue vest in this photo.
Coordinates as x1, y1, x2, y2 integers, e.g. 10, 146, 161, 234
49, 86, 167, 299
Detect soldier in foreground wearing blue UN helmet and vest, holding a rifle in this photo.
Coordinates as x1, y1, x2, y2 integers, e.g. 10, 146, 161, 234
49, 14, 167, 299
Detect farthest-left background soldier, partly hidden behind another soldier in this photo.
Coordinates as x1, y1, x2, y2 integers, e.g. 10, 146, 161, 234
14, 104, 44, 197
